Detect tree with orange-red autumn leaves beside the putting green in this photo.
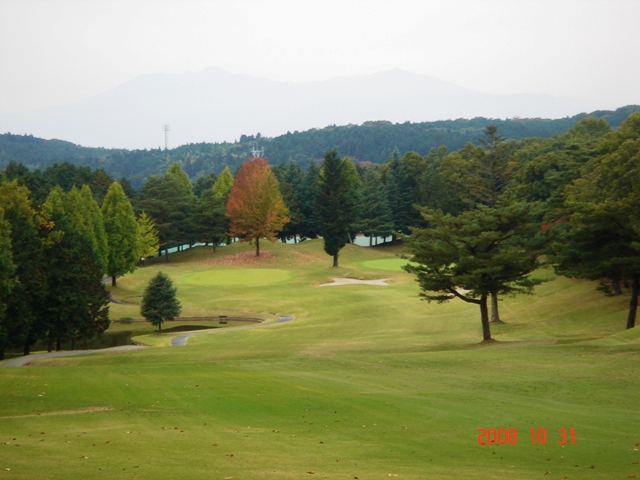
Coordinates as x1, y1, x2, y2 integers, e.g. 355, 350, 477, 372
227, 158, 290, 256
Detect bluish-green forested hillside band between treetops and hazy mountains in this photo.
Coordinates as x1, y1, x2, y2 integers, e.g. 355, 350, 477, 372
0, 106, 640, 187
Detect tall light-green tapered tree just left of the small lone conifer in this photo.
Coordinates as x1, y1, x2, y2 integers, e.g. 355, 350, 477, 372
102, 182, 140, 287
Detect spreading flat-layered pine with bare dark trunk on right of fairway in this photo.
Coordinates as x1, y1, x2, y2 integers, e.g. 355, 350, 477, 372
404, 203, 545, 341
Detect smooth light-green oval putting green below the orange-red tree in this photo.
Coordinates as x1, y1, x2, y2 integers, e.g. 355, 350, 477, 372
178, 268, 293, 285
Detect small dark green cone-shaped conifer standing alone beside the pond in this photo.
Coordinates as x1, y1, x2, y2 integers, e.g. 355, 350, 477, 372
140, 272, 182, 332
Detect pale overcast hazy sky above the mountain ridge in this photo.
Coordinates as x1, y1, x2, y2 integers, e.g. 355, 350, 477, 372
0, 0, 640, 113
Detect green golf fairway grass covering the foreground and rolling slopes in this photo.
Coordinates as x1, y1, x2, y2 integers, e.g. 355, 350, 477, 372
0, 241, 640, 479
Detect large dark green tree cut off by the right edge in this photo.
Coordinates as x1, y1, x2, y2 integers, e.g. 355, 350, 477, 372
552, 113, 640, 328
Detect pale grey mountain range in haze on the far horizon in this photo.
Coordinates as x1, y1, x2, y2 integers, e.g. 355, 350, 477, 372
0, 68, 582, 149
